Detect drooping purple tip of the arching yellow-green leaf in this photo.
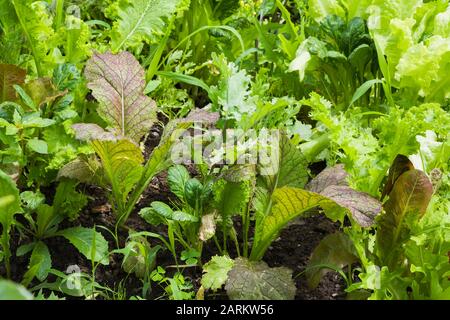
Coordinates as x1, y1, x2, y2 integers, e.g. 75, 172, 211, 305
320, 186, 381, 227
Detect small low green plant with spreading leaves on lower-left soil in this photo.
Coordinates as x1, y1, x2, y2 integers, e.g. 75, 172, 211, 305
16, 180, 109, 286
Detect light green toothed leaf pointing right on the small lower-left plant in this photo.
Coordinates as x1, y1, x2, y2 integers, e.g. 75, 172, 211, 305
57, 227, 109, 265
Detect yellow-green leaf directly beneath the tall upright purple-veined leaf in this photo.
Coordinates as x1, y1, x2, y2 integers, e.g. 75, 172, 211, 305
92, 139, 144, 199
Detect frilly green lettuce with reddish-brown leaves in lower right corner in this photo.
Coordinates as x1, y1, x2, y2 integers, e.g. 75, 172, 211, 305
306, 155, 450, 299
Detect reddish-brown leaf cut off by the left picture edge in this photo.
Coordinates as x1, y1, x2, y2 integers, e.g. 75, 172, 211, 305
0, 64, 26, 102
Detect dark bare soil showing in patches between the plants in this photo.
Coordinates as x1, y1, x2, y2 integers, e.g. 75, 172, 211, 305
0, 119, 345, 300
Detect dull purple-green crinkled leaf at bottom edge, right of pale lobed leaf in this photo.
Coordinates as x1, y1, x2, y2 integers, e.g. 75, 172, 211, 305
225, 258, 296, 300
